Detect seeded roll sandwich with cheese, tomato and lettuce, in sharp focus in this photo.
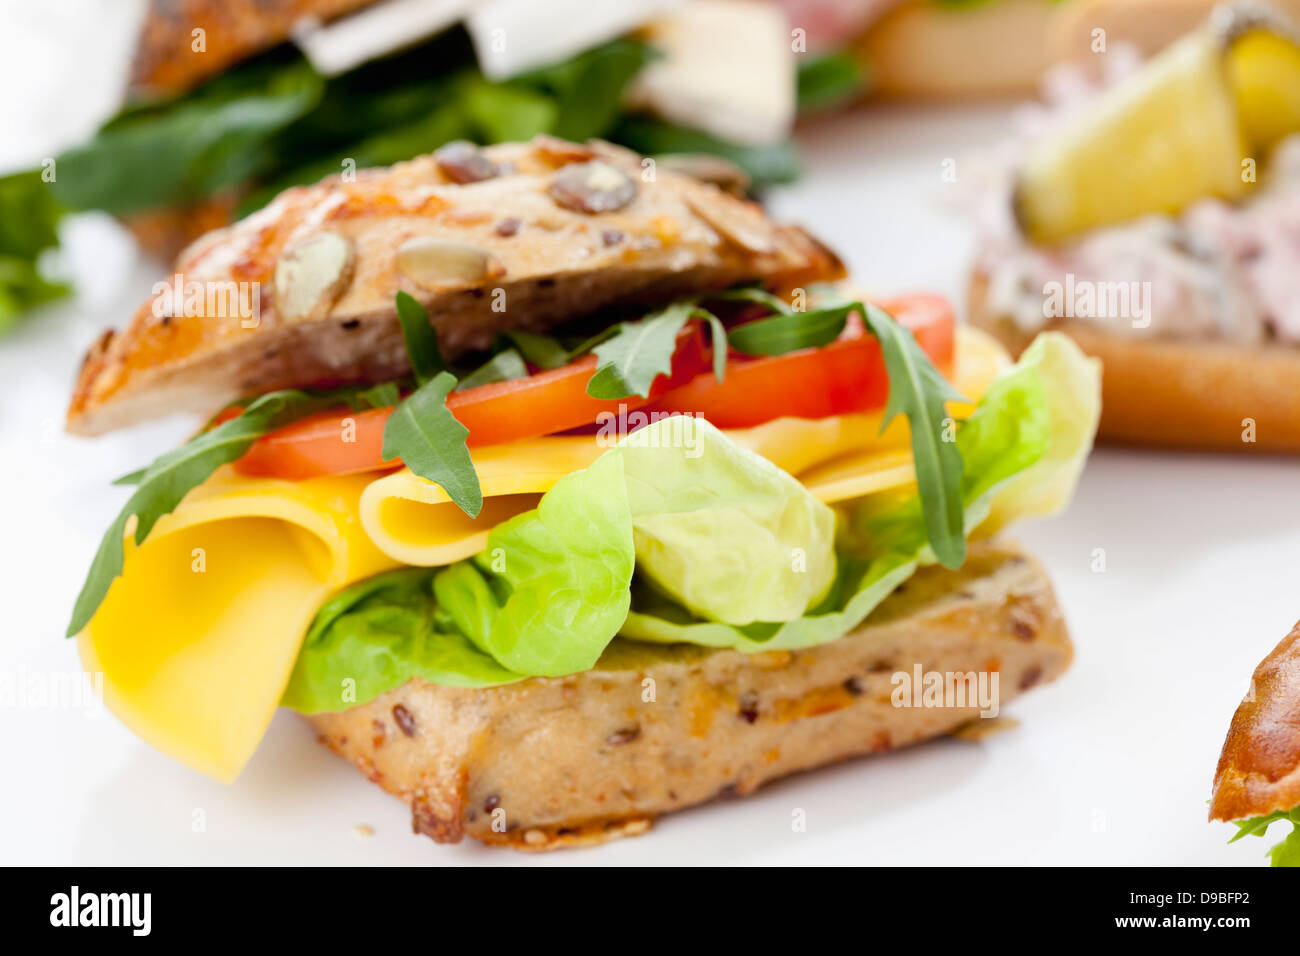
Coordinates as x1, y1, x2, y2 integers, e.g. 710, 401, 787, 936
68, 138, 1100, 849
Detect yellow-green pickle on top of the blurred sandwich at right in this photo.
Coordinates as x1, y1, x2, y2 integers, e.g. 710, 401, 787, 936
1013, 8, 1300, 243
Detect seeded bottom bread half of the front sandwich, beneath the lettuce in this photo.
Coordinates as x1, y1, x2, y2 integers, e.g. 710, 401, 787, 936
308, 540, 1071, 849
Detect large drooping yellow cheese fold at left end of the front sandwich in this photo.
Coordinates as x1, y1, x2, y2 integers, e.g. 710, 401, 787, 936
78, 467, 398, 780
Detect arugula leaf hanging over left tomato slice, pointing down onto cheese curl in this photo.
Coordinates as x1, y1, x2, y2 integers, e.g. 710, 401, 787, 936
379, 372, 484, 518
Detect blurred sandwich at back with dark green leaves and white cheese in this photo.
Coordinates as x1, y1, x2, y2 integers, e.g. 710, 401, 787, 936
0, 0, 862, 324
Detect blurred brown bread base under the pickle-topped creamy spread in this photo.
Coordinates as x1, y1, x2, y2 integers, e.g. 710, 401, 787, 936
969, 272, 1300, 453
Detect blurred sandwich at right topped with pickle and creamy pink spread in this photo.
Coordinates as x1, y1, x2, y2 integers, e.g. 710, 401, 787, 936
970, 4, 1300, 451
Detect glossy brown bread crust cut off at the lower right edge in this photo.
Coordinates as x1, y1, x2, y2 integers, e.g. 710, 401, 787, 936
1210, 624, 1300, 819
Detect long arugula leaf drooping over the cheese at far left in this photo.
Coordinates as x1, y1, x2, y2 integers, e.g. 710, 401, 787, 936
68, 389, 337, 637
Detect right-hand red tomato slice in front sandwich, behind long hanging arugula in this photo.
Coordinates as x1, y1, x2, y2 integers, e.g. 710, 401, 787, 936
647, 295, 954, 428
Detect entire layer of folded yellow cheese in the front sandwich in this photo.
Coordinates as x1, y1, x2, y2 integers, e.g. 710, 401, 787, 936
78, 330, 1008, 780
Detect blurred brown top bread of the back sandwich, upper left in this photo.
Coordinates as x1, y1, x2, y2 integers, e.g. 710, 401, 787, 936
129, 0, 376, 98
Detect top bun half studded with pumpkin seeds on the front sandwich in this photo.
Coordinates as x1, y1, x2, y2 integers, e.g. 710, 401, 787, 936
68, 137, 844, 434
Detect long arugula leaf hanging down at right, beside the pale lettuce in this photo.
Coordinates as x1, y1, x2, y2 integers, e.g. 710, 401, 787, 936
853, 302, 966, 568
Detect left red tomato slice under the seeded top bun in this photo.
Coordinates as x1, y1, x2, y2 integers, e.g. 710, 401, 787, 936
235, 324, 709, 480
